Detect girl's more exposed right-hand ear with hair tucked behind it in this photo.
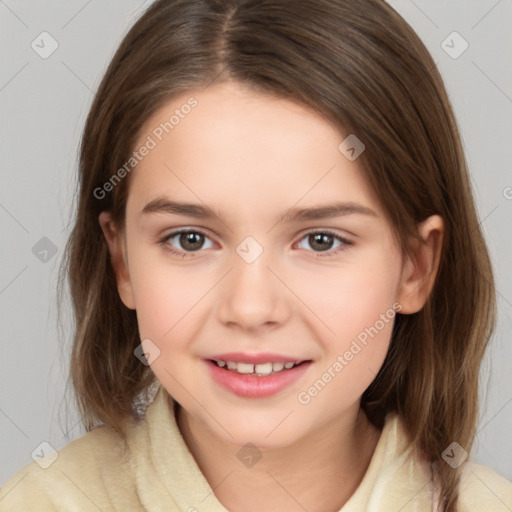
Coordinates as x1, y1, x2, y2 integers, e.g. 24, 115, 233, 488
397, 215, 444, 314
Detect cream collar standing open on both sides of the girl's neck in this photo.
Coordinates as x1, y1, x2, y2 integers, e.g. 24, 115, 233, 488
128, 384, 432, 512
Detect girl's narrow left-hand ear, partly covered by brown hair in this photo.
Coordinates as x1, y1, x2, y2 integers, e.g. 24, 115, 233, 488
98, 211, 135, 309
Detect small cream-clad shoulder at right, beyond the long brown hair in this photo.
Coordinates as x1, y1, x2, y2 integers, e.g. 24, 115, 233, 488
459, 462, 512, 512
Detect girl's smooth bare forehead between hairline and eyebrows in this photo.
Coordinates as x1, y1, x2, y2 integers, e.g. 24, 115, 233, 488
129, 83, 384, 221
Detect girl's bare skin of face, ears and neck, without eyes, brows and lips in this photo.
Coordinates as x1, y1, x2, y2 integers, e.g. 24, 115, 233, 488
99, 83, 443, 512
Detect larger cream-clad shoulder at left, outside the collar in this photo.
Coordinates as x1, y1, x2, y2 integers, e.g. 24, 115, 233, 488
0, 425, 139, 512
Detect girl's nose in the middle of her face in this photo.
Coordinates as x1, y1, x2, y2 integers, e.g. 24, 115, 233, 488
217, 243, 293, 331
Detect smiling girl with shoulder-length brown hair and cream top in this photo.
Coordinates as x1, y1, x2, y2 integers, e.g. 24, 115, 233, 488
0, 0, 512, 512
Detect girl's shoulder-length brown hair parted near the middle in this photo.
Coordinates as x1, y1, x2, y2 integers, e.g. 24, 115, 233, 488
59, 0, 495, 512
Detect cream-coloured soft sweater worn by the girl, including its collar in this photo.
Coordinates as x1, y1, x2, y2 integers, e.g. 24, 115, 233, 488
0, 386, 512, 512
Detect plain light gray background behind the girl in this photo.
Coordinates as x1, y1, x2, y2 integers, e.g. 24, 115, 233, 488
0, 0, 512, 485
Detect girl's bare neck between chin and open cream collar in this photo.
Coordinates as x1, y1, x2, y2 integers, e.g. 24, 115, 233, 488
176, 404, 380, 512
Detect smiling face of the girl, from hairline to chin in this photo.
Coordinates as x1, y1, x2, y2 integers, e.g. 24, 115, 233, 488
102, 83, 440, 448
